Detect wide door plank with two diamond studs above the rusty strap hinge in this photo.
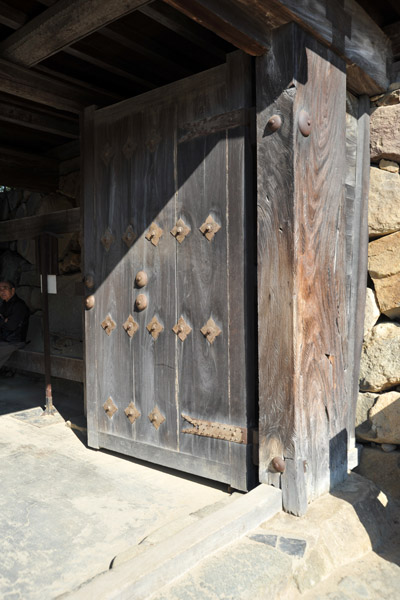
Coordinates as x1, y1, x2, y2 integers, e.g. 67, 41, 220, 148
177, 131, 229, 462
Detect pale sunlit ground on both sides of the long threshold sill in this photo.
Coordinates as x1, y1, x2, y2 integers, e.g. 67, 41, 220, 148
0, 376, 400, 600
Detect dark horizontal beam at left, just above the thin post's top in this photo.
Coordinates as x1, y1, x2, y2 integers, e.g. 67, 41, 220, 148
0, 208, 80, 242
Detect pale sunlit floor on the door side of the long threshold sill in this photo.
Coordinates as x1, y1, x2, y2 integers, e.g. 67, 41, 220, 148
0, 377, 230, 600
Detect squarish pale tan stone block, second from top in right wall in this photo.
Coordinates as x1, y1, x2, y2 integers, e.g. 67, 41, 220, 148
368, 167, 400, 237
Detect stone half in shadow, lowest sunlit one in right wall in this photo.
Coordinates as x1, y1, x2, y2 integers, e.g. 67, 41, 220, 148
356, 391, 400, 444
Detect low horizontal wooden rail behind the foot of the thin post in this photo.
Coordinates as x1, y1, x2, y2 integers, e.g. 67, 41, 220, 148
7, 350, 84, 382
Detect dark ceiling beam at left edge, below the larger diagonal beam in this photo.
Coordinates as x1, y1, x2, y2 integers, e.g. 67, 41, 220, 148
0, 58, 116, 114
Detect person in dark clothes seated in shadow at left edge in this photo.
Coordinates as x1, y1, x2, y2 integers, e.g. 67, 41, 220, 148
0, 281, 29, 368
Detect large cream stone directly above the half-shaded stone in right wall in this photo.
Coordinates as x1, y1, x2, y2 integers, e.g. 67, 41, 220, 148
360, 323, 400, 392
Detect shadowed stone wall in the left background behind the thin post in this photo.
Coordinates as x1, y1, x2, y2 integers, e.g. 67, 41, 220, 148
0, 166, 83, 358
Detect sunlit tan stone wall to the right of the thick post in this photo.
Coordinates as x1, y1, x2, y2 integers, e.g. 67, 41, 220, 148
356, 83, 400, 499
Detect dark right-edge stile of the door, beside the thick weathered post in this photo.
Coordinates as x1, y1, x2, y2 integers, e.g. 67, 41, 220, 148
226, 52, 257, 489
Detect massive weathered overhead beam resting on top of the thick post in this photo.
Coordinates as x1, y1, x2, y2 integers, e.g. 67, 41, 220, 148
164, 0, 392, 95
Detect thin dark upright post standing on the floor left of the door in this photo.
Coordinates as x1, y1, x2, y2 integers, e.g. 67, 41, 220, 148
39, 234, 55, 415
